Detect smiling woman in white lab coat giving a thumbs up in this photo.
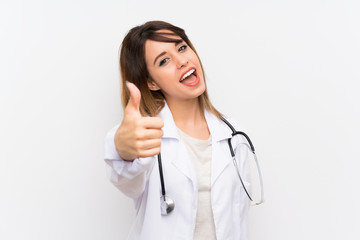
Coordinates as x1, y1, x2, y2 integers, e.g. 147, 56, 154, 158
105, 21, 249, 240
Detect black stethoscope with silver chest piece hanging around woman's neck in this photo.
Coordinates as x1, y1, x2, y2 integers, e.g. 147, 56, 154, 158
158, 117, 264, 215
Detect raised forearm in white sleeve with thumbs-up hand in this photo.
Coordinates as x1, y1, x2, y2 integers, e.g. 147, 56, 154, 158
105, 83, 164, 198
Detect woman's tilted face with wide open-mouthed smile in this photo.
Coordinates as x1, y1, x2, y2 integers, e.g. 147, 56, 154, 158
145, 30, 205, 102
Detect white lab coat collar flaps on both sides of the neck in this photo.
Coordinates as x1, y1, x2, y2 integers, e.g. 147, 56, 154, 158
158, 102, 231, 141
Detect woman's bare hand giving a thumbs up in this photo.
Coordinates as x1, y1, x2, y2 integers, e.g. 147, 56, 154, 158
114, 82, 164, 161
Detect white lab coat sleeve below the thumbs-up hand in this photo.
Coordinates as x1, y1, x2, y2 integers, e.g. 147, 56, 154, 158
104, 125, 155, 199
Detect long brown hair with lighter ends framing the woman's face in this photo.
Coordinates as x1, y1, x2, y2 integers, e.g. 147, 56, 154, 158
120, 21, 222, 118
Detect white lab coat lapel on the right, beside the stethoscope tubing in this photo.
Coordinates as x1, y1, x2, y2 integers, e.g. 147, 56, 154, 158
205, 111, 231, 186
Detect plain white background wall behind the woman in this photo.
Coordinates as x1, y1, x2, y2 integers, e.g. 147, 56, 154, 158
0, 0, 360, 240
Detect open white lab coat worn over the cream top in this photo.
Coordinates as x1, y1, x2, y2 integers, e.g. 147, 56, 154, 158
105, 104, 250, 240
